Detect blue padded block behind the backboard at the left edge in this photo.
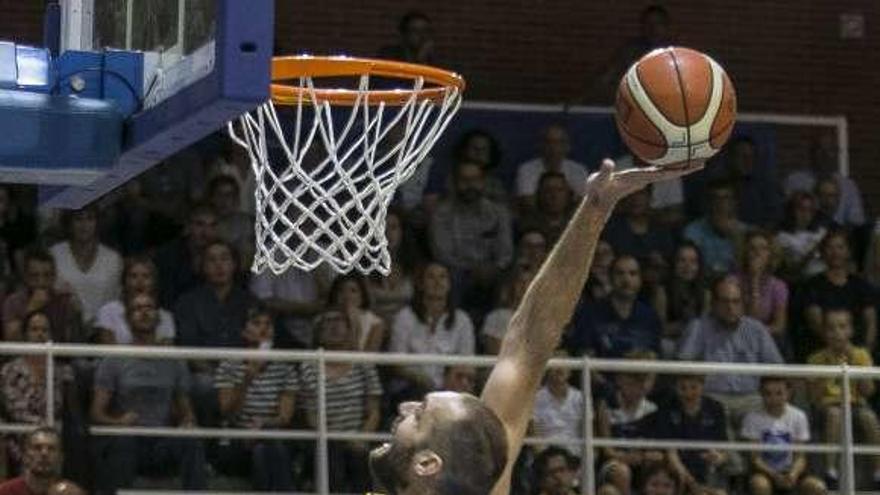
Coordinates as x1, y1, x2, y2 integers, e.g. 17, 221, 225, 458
0, 89, 123, 184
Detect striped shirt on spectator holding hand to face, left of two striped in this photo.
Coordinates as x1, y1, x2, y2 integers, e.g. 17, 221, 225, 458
214, 361, 299, 426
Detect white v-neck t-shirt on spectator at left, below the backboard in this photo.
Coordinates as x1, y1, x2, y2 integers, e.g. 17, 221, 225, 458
49, 241, 122, 322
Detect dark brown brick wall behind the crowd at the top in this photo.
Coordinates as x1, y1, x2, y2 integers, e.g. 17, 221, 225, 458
0, 0, 880, 211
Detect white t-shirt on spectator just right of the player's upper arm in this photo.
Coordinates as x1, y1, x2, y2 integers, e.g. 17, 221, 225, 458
532, 386, 584, 457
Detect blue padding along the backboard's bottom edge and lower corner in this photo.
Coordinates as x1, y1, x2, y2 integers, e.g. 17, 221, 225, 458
40, 0, 275, 208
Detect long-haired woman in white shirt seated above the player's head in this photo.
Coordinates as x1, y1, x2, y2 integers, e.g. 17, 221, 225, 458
389, 262, 475, 398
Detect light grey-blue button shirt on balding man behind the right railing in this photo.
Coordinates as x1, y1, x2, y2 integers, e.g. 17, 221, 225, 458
678, 315, 783, 394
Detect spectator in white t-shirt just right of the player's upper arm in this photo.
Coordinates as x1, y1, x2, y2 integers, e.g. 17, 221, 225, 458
531, 351, 584, 456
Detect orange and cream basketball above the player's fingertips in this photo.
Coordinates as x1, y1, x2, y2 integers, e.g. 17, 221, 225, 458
614, 47, 736, 169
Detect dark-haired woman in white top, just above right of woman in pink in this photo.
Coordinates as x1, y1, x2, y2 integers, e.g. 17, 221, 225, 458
776, 191, 827, 282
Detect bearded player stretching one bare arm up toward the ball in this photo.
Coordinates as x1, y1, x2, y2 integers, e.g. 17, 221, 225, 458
370, 160, 703, 495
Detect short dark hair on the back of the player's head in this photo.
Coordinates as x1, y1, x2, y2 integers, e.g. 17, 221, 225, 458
424, 394, 507, 495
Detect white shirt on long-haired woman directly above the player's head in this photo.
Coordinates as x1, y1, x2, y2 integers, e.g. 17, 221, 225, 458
389, 306, 474, 389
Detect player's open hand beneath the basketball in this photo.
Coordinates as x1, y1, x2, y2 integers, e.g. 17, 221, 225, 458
586, 158, 705, 209
